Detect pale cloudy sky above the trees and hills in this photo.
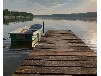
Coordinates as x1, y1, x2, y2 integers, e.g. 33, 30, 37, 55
3, 0, 97, 15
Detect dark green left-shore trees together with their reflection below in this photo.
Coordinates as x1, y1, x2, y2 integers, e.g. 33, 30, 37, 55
3, 9, 33, 25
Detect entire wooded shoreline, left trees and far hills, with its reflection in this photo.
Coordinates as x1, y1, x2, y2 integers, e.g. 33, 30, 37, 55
3, 9, 97, 25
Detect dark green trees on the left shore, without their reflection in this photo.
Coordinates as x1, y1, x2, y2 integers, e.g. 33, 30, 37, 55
3, 9, 33, 18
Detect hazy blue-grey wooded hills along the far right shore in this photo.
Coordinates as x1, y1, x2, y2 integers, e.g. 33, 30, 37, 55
34, 12, 97, 18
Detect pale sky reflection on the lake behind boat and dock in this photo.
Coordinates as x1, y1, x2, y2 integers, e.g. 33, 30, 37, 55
3, 17, 97, 50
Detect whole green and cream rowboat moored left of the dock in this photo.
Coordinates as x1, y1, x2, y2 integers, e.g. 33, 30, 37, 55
9, 24, 43, 49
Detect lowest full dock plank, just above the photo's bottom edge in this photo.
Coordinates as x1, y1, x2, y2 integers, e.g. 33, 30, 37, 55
16, 66, 97, 74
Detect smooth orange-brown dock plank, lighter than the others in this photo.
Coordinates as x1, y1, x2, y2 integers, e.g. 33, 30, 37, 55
29, 49, 96, 56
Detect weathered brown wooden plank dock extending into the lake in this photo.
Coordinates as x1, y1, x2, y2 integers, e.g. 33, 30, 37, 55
13, 30, 97, 76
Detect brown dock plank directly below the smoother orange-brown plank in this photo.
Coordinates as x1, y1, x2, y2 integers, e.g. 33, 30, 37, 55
26, 55, 97, 61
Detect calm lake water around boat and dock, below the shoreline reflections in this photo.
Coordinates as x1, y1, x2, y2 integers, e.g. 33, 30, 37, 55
3, 18, 97, 76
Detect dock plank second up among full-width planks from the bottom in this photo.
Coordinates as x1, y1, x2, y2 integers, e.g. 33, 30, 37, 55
22, 60, 97, 68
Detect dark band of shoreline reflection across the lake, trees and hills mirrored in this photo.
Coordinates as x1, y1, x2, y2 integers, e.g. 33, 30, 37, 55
3, 17, 97, 25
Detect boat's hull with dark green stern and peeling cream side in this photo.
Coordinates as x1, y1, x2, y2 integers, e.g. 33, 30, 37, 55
10, 29, 42, 49
